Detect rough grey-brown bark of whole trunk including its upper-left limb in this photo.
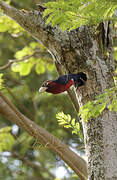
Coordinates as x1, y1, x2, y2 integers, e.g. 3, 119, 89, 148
0, 1, 117, 180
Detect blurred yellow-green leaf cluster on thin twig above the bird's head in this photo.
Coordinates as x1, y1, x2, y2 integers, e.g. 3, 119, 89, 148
12, 42, 54, 76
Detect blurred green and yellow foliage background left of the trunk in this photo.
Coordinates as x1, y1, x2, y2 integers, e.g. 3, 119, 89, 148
0, 0, 84, 180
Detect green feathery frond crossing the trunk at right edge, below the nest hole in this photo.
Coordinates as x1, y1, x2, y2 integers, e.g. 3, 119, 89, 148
79, 87, 117, 121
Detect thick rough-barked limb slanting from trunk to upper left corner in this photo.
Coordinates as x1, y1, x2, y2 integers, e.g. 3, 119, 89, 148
0, 1, 69, 67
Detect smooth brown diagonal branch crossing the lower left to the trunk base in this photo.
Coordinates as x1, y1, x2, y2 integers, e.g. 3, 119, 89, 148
0, 92, 87, 180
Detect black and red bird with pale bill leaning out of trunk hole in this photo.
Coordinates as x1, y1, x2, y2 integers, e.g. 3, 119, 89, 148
39, 72, 87, 94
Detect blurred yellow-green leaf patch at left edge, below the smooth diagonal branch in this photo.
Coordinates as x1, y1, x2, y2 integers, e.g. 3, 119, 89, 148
0, 127, 15, 152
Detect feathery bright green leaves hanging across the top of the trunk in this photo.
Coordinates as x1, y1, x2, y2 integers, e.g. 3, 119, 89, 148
44, 0, 117, 31
